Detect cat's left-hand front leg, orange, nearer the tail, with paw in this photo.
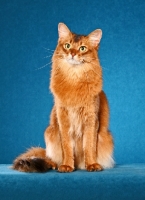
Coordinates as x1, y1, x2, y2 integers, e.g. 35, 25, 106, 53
57, 107, 74, 172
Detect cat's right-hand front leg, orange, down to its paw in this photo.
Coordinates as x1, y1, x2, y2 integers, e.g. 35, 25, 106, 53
83, 112, 103, 171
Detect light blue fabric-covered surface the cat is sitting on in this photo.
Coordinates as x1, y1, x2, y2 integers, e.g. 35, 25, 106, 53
0, 164, 145, 200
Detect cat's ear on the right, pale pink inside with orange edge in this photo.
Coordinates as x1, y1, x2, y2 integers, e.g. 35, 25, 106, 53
89, 29, 102, 47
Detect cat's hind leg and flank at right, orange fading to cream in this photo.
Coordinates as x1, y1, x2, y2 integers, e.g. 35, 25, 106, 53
97, 91, 114, 169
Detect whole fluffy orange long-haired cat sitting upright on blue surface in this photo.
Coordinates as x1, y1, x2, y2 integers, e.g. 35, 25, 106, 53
13, 23, 114, 172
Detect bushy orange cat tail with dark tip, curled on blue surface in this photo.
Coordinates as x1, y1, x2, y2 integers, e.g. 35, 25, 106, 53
12, 147, 57, 172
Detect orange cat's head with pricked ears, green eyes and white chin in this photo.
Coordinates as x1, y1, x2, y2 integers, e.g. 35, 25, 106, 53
55, 23, 102, 66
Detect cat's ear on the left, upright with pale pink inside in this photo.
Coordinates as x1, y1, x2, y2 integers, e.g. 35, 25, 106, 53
58, 23, 70, 39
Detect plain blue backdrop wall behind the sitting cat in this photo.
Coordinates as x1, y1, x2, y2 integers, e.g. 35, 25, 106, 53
0, 0, 145, 164
